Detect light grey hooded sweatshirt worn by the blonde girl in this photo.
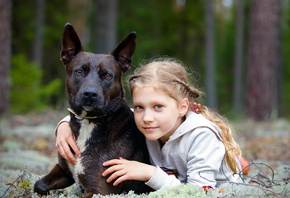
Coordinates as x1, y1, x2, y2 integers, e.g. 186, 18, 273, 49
146, 112, 242, 190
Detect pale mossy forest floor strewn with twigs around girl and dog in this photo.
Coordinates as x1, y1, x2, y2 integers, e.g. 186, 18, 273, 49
0, 111, 290, 198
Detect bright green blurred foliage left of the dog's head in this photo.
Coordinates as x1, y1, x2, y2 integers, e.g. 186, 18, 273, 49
10, 55, 62, 113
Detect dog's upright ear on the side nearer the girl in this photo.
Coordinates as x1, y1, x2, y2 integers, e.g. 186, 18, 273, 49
111, 32, 136, 73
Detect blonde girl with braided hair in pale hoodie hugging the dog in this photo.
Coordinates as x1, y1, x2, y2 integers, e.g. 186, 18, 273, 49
57, 59, 241, 190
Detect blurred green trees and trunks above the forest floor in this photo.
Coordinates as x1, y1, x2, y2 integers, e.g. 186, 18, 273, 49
0, 0, 290, 120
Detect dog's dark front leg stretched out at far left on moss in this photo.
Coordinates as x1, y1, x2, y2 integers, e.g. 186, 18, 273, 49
34, 164, 75, 195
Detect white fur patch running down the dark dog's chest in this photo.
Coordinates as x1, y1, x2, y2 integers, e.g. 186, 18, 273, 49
70, 119, 96, 183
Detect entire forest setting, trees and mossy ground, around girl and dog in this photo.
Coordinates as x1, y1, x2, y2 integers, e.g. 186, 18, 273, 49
0, 0, 290, 197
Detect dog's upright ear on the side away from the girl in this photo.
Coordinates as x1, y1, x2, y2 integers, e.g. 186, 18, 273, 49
60, 23, 83, 65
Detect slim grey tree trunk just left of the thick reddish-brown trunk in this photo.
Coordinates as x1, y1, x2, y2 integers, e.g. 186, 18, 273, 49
233, 0, 244, 114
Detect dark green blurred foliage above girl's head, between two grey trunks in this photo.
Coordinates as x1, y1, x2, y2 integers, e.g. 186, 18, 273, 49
117, 0, 205, 104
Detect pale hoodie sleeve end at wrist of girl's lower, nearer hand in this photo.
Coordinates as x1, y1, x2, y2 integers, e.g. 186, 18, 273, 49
145, 166, 181, 190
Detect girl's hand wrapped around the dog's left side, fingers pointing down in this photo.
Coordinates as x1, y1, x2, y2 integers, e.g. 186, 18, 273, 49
56, 122, 81, 164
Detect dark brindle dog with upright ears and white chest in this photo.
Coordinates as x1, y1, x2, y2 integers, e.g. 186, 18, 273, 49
34, 23, 151, 197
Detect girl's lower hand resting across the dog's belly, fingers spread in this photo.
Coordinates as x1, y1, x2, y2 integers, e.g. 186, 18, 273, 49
102, 157, 156, 186
